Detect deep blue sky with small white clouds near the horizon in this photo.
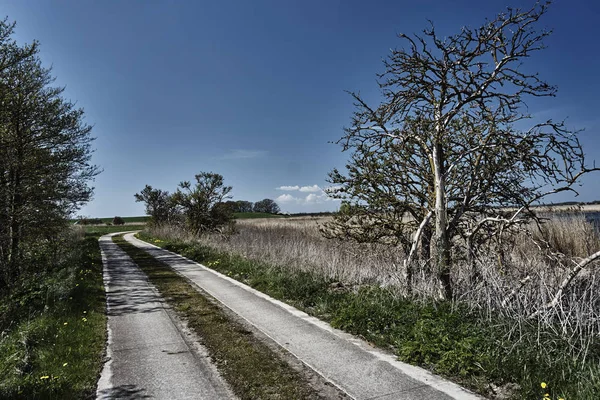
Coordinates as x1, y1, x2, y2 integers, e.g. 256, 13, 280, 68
0, 0, 600, 217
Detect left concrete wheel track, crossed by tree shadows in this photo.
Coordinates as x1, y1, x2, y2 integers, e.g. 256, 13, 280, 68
96, 234, 233, 400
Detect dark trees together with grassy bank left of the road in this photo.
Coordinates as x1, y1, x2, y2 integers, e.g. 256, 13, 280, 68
0, 19, 106, 399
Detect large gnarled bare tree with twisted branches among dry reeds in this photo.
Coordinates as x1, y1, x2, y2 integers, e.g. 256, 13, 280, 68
325, 3, 595, 298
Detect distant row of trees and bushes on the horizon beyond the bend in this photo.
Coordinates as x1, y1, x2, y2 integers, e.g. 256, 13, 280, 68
134, 172, 280, 235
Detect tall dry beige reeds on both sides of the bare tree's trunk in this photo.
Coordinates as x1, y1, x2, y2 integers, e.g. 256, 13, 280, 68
150, 214, 600, 360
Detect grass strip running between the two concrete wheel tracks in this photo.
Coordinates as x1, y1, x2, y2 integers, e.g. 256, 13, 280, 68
113, 236, 320, 400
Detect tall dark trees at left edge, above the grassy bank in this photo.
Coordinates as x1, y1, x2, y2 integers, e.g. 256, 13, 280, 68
0, 19, 99, 293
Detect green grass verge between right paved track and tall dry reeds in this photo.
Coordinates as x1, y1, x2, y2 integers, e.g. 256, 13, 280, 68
139, 232, 600, 399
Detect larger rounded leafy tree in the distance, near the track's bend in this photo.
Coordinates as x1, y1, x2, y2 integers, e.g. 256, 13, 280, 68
173, 172, 233, 235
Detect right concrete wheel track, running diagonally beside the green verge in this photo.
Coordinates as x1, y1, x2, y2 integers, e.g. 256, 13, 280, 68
125, 234, 480, 400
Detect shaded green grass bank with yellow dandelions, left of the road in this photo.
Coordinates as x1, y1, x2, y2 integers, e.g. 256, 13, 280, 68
0, 231, 106, 399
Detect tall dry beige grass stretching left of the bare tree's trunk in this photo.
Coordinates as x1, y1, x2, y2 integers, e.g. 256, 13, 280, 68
151, 217, 404, 286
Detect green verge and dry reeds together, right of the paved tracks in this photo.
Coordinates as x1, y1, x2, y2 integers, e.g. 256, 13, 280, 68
139, 214, 600, 399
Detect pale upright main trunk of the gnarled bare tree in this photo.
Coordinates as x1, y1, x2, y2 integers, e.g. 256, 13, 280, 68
433, 143, 452, 300
